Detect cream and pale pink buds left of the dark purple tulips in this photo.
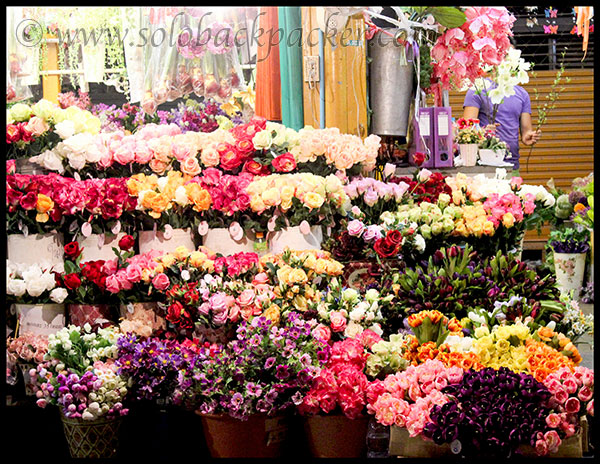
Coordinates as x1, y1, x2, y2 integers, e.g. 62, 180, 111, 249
317, 277, 392, 340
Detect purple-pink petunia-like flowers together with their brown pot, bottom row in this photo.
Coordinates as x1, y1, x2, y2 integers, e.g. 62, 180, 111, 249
174, 314, 329, 457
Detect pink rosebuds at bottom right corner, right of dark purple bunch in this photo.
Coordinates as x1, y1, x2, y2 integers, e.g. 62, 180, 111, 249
535, 366, 594, 455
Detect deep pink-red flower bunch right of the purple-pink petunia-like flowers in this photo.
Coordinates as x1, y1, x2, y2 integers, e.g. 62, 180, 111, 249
298, 339, 370, 419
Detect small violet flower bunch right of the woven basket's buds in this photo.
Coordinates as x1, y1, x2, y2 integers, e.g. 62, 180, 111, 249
115, 334, 199, 400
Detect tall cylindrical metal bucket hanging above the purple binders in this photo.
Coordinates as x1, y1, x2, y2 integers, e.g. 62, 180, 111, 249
368, 29, 414, 136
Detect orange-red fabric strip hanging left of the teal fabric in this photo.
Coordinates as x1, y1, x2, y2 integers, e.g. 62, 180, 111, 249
254, 6, 285, 121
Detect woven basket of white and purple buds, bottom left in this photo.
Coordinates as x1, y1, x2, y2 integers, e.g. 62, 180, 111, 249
31, 324, 129, 458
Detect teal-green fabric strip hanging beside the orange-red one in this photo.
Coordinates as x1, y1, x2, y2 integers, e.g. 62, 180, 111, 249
278, 6, 304, 130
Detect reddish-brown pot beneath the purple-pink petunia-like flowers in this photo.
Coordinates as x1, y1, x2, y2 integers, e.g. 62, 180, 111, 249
197, 412, 288, 458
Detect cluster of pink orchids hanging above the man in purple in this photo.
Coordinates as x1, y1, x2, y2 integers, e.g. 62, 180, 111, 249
431, 7, 516, 89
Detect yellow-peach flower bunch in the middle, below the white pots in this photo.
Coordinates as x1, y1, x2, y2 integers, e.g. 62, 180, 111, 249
259, 249, 343, 318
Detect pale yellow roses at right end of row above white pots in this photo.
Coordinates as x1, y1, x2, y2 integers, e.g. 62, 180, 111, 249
246, 173, 348, 232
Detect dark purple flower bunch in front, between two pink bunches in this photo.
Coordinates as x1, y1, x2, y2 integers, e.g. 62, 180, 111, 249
423, 367, 552, 457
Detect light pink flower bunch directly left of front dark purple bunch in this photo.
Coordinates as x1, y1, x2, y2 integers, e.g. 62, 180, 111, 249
367, 360, 463, 437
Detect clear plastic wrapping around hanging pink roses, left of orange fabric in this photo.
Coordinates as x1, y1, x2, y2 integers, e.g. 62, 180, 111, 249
141, 7, 244, 114
